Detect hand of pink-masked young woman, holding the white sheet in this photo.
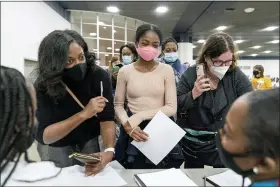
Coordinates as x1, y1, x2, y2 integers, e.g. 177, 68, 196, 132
124, 122, 149, 142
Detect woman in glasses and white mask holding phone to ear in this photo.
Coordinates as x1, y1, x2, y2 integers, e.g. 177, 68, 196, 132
177, 32, 253, 168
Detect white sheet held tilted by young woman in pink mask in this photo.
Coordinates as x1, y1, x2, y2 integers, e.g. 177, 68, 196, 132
132, 111, 185, 165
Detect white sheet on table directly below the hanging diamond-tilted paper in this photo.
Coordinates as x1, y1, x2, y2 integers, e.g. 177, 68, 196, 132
137, 168, 197, 186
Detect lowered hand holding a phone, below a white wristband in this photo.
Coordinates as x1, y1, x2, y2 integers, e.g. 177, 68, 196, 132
85, 151, 114, 176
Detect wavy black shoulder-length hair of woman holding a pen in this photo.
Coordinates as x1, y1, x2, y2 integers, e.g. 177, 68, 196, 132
35, 30, 96, 100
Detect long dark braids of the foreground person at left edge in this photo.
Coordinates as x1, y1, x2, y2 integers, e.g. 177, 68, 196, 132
0, 66, 35, 183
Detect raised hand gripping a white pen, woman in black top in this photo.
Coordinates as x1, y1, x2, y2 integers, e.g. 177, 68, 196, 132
82, 96, 108, 119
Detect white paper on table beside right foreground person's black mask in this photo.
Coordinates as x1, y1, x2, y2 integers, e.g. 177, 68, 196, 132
207, 170, 251, 186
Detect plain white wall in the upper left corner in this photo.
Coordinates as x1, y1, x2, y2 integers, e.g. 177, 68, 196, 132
1, 2, 71, 73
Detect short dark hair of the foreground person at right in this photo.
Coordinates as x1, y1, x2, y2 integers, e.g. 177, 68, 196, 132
244, 88, 280, 158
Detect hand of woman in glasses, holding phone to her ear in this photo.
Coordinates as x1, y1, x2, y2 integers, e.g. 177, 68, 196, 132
192, 75, 211, 100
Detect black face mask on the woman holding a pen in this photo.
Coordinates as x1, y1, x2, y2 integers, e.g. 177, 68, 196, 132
64, 63, 87, 81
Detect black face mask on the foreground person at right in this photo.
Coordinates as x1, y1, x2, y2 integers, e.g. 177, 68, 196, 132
215, 133, 255, 178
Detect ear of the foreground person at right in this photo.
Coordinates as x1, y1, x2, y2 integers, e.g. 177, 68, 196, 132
254, 157, 279, 175
